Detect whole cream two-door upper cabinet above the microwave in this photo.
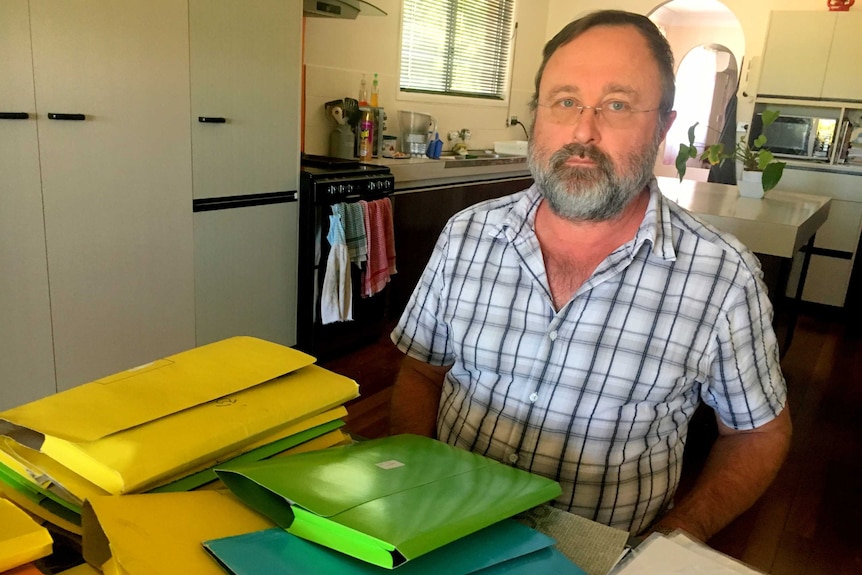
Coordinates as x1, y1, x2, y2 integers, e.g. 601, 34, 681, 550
757, 11, 862, 100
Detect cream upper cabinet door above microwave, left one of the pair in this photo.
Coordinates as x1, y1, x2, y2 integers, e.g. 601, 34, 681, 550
757, 11, 835, 98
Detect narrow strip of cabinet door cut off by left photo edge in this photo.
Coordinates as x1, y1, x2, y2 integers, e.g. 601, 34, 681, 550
0, 0, 56, 410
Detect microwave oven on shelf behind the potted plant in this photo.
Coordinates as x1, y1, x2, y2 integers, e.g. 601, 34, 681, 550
748, 113, 838, 160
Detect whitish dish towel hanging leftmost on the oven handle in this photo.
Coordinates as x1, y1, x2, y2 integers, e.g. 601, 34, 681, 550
320, 214, 353, 325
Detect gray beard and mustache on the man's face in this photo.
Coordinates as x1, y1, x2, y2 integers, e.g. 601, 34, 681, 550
527, 134, 661, 222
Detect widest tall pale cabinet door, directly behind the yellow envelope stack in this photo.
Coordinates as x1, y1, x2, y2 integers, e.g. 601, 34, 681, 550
30, 0, 194, 390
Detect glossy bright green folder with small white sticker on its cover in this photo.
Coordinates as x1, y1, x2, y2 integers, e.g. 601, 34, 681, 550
216, 435, 561, 569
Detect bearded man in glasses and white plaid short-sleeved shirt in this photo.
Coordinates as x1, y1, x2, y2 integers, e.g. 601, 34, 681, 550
391, 7, 791, 540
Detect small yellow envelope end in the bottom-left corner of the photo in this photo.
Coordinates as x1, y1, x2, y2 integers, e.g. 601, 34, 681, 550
0, 497, 54, 571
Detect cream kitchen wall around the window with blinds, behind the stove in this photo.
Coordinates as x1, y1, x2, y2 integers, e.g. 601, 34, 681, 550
304, 0, 548, 154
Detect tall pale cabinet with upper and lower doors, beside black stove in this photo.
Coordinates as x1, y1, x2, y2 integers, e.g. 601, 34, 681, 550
189, 0, 302, 345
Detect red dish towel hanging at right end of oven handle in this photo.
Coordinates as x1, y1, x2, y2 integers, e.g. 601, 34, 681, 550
361, 198, 396, 297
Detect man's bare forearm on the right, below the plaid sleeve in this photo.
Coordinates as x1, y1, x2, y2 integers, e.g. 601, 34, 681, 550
657, 407, 792, 541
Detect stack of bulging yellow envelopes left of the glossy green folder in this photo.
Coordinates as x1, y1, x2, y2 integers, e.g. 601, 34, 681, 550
0, 337, 358, 534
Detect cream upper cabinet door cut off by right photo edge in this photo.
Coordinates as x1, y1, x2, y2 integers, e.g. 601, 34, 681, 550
823, 12, 862, 100
